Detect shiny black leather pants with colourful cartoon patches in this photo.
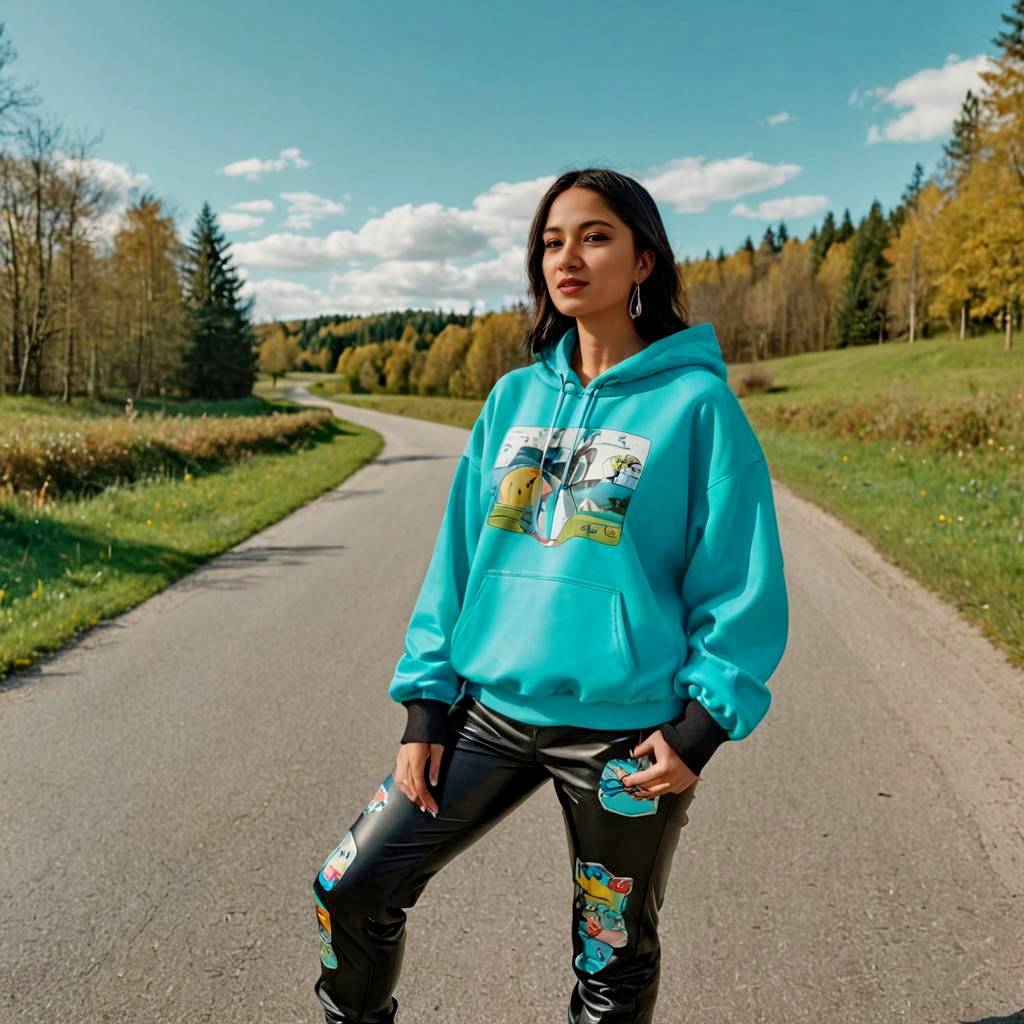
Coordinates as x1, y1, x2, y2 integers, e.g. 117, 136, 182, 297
313, 694, 700, 1024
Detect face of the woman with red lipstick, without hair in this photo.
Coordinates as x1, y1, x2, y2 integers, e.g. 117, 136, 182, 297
543, 185, 649, 317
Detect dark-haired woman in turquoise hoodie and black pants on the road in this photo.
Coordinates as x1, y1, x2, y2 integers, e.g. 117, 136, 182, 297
313, 168, 788, 1024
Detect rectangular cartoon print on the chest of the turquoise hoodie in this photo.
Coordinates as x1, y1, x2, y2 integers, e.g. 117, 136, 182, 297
486, 426, 650, 545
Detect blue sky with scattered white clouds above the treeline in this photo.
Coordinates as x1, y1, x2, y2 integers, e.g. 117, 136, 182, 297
0, 0, 1011, 321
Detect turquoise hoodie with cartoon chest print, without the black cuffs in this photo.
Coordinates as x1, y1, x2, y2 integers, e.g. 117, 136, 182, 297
388, 323, 788, 739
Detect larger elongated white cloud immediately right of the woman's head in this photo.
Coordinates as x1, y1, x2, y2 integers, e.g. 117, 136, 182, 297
639, 153, 803, 213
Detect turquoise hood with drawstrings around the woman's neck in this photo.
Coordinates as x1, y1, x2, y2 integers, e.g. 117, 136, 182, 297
532, 321, 729, 540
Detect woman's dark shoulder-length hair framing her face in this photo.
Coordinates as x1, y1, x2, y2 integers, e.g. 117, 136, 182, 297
522, 167, 689, 357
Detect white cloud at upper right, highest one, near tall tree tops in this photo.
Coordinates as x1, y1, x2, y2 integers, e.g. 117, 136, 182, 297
851, 53, 992, 145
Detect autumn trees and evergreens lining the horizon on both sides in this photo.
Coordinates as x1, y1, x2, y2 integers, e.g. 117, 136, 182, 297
0, 0, 1024, 400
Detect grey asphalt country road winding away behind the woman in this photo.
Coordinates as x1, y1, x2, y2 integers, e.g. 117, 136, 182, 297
0, 385, 1024, 1024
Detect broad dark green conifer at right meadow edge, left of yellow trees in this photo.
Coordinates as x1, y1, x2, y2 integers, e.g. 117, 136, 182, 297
833, 200, 890, 348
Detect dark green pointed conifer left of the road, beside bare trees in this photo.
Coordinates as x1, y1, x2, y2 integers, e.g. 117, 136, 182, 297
184, 203, 259, 399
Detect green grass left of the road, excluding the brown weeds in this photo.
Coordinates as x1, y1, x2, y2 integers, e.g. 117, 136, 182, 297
0, 389, 382, 678
